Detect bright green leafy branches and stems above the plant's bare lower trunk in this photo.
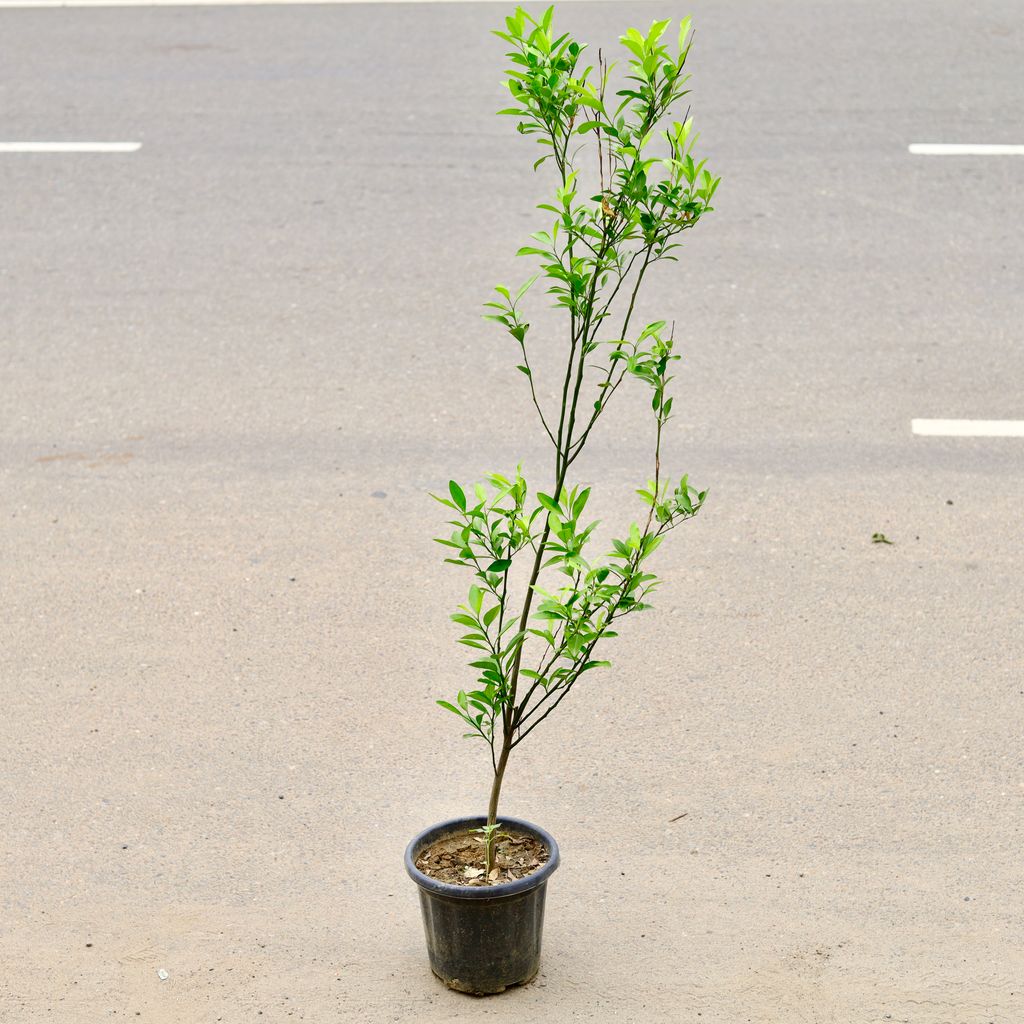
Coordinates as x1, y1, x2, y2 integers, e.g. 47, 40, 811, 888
435, 8, 720, 781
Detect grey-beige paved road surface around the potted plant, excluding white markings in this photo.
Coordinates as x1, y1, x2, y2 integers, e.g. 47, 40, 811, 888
0, 0, 1024, 1024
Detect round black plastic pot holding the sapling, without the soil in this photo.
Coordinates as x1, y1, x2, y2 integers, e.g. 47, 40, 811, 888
406, 817, 558, 995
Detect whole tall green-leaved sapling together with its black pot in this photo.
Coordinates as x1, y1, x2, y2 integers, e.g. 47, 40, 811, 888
406, 8, 719, 993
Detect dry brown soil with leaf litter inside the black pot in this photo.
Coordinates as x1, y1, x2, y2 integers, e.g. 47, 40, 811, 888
416, 829, 549, 886
